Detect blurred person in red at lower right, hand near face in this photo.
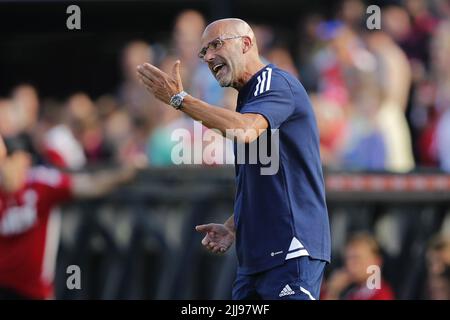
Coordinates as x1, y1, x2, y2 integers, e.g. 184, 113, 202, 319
323, 232, 394, 300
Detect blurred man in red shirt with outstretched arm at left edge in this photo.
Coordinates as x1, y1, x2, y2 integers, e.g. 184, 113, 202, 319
0, 136, 135, 300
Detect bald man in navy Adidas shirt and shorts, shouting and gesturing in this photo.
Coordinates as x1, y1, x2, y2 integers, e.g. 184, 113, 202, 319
137, 19, 330, 300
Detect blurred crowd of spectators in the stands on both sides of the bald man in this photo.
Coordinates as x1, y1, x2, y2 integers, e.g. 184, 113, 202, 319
0, 0, 450, 172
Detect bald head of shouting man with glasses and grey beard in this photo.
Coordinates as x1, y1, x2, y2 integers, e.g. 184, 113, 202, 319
201, 18, 262, 90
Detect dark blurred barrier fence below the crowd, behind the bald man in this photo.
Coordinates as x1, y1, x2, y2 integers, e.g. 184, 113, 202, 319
56, 166, 450, 299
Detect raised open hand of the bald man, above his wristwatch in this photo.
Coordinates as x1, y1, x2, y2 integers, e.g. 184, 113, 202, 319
137, 60, 183, 104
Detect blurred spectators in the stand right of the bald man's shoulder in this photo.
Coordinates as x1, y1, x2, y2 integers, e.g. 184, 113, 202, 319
304, 0, 450, 172
